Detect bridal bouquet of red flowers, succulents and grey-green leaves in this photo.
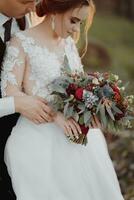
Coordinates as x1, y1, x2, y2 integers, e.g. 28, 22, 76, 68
51, 58, 134, 145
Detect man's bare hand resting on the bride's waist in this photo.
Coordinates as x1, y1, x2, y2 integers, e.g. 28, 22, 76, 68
14, 95, 54, 124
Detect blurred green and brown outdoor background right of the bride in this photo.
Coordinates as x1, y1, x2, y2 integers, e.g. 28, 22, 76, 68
78, 0, 134, 200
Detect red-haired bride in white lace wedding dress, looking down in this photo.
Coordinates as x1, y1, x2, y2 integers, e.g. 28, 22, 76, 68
2, 0, 123, 200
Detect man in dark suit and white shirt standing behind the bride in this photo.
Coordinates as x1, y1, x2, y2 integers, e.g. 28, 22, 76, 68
0, 0, 52, 200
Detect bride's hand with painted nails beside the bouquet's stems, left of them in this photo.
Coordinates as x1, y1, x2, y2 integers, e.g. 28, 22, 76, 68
54, 112, 82, 140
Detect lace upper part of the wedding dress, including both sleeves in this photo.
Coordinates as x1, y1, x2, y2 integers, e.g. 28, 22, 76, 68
1, 32, 83, 99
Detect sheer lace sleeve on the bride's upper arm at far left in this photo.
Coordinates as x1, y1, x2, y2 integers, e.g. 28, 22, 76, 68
1, 37, 25, 97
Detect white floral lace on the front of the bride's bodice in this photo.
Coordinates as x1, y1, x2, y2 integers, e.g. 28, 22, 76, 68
16, 32, 61, 98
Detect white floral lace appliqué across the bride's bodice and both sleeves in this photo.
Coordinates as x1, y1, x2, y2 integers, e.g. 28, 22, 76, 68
2, 32, 83, 98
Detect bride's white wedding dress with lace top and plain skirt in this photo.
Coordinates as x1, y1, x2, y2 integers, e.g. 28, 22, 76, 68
2, 32, 123, 200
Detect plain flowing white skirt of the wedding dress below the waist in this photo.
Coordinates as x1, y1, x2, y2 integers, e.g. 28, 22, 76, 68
5, 117, 123, 200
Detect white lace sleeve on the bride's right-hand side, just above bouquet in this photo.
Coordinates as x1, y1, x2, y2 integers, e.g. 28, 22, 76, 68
66, 37, 84, 72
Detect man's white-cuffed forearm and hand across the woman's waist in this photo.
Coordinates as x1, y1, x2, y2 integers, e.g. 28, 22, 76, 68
0, 95, 52, 123
